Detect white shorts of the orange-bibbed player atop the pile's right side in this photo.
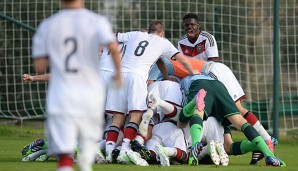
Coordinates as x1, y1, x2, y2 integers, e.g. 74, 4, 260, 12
207, 62, 245, 102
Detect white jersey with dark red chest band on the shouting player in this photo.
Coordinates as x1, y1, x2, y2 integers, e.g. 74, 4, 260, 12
178, 31, 218, 61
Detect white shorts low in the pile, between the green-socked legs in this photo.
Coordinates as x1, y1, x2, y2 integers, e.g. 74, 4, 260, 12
201, 117, 224, 144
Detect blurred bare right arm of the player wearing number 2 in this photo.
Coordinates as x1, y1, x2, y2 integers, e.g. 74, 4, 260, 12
107, 42, 123, 87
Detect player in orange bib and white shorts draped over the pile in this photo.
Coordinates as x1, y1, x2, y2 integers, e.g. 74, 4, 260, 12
152, 58, 274, 157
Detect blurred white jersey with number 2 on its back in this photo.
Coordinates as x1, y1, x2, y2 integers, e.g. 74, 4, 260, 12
32, 9, 115, 117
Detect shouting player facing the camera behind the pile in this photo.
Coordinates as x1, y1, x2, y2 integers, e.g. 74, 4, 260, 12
178, 13, 219, 61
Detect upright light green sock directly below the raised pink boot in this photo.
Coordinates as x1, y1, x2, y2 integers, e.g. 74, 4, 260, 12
190, 115, 203, 145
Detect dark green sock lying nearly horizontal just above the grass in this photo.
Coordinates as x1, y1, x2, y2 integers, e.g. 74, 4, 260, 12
230, 140, 259, 155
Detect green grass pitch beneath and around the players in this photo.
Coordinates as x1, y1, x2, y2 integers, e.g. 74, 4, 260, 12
0, 122, 298, 171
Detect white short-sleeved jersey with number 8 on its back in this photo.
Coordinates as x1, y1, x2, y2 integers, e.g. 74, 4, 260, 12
117, 31, 179, 79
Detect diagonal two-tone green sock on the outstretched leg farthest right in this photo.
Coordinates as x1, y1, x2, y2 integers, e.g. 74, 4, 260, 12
241, 123, 274, 156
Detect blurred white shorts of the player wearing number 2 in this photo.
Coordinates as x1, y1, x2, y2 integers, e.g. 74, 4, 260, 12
45, 115, 104, 155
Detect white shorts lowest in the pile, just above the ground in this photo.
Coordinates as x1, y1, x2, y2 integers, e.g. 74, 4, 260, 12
145, 122, 186, 151
